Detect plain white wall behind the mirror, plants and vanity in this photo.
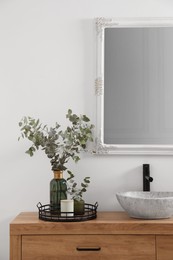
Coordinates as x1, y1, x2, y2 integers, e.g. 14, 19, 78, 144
0, 0, 173, 260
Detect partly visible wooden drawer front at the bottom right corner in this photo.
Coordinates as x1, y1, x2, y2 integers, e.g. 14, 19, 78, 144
156, 235, 173, 260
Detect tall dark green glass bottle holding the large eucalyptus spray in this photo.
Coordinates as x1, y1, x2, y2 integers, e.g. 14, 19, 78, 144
50, 171, 67, 210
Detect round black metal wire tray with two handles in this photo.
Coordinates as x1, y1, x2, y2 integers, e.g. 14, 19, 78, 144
37, 202, 98, 222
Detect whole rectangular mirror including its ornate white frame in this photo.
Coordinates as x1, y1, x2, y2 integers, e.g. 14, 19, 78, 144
95, 18, 173, 154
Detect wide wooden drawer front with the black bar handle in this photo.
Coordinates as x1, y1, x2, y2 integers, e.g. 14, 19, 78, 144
22, 235, 155, 260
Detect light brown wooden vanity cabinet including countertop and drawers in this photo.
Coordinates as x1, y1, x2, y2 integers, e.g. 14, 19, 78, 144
10, 212, 173, 260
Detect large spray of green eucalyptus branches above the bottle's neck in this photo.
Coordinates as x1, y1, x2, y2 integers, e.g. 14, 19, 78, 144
19, 109, 94, 170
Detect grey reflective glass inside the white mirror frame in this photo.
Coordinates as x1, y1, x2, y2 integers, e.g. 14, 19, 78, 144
103, 27, 173, 145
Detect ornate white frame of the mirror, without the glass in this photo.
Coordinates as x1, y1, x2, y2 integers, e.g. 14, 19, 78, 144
95, 17, 173, 155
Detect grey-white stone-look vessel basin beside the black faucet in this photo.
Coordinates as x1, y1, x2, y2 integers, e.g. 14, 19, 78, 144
116, 191, 173, 219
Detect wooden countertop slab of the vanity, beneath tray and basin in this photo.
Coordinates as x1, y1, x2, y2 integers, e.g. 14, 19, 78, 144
10, 212, 173, 235
